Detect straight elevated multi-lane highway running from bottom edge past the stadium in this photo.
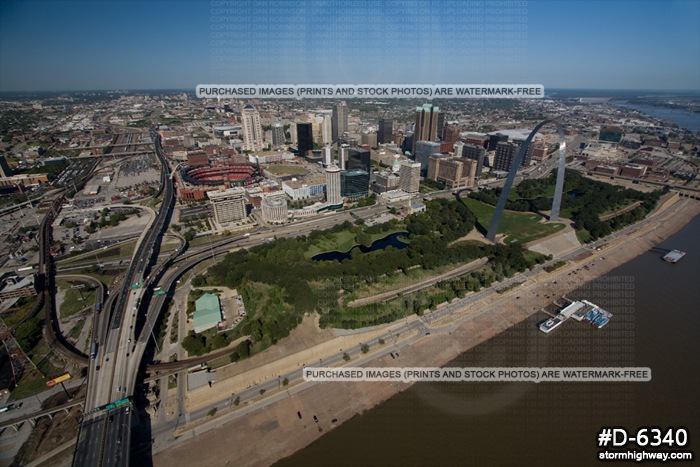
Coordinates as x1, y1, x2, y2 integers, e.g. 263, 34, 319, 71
73, 131, 175, 466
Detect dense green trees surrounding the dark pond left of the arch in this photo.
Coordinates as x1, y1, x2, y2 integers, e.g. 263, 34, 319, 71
193, 199, 484, 350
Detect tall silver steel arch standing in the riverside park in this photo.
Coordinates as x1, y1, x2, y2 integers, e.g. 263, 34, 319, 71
486, 120, 566, 242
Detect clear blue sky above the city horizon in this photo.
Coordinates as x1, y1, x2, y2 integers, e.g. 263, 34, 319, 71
0, 0, 700, 91
